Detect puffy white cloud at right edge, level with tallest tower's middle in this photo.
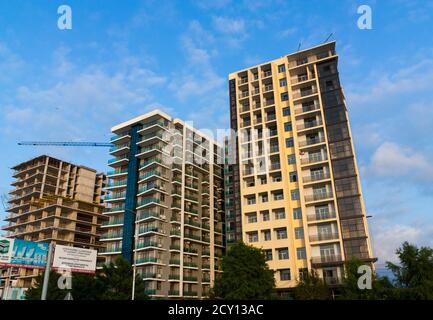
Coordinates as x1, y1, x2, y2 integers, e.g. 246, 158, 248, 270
369, 142, 433, 181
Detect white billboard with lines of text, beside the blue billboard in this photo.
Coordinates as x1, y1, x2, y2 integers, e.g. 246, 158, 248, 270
53, 245, 97, 273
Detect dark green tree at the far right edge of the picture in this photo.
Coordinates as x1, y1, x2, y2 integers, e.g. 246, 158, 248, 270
386, 242, 433, 300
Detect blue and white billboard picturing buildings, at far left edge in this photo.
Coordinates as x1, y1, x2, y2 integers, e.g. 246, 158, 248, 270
0, 238, 49, 269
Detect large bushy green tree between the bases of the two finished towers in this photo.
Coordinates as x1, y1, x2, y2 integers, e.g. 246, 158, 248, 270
210, 242, 275, 300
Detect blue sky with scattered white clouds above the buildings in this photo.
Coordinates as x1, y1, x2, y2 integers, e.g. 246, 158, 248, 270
0, 0, 433, 261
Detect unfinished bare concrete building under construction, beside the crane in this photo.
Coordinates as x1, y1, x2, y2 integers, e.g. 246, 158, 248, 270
0, 155, 106, 298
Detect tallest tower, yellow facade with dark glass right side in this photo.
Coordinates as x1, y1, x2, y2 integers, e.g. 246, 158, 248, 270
226, 42, 375, 292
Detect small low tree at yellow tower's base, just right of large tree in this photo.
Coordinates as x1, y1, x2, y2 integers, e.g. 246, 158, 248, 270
293, 270, 332, 300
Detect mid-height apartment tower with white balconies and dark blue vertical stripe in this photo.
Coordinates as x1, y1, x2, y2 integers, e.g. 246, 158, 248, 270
100, 110, 224, 298
